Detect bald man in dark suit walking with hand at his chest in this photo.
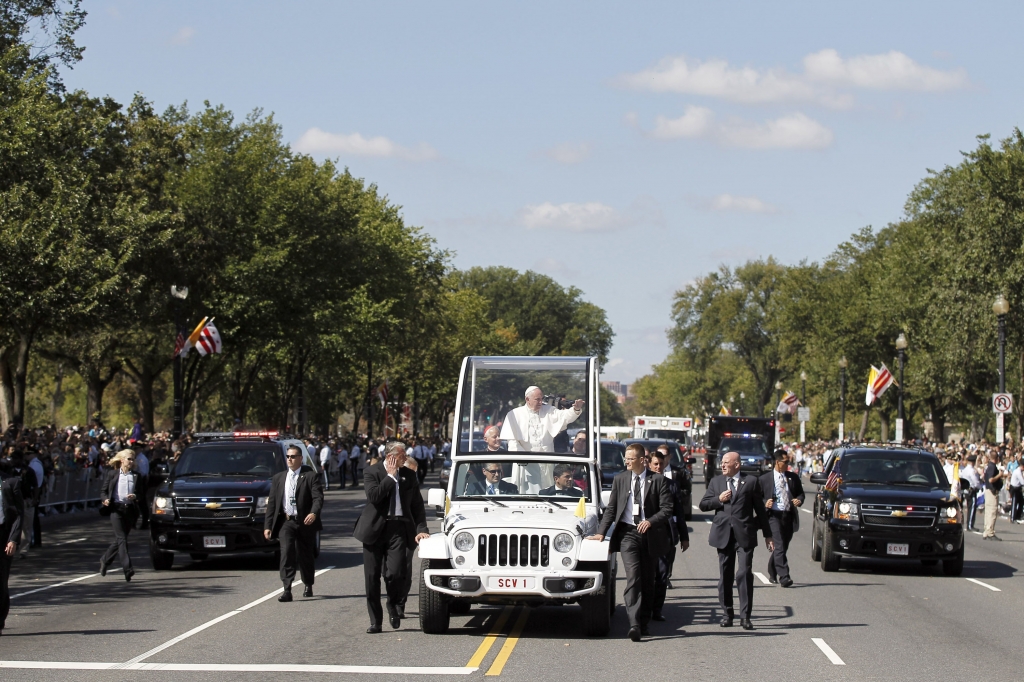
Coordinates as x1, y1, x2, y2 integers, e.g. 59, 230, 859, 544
698, 453, 773, 630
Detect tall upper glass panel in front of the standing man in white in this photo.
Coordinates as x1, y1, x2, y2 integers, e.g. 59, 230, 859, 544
457, 357, 593, 457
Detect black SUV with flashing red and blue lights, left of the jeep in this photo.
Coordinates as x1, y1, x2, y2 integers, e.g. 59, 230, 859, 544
150, 431, 319, 570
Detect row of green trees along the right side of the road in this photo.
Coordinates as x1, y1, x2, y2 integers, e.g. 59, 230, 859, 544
634, 130, 1024, 440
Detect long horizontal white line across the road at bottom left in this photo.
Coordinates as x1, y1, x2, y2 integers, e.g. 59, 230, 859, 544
0, 660, 471, 675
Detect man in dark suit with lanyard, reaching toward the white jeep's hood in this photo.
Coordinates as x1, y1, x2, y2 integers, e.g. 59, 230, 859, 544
588, 443, 672, 642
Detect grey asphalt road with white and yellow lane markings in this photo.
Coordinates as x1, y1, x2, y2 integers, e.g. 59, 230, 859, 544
0, 473, 1024, 682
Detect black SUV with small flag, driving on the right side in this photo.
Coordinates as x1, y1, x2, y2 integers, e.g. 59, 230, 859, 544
811, 446, 964, 576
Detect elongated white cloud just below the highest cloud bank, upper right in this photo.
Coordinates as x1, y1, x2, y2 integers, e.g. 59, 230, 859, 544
651, 105, 834, 150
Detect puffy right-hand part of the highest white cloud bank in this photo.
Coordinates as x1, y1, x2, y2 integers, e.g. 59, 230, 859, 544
804, 49, 970, 92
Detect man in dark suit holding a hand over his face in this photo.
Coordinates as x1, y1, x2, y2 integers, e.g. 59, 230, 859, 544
352, 440, 430, 634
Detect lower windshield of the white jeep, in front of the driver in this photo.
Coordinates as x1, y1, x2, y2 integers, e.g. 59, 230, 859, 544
452, 460, 591, 503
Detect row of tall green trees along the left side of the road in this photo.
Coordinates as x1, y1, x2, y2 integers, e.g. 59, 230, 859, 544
0, 0, 612, 432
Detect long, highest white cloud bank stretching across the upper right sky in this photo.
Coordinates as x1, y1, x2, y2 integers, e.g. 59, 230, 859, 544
618, 49, 970, 109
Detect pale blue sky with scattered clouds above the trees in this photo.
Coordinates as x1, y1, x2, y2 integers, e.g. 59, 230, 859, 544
65, 0, 1024, 381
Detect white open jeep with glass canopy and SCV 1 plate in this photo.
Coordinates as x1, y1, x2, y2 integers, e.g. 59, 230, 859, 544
419, 357, 616, 636
